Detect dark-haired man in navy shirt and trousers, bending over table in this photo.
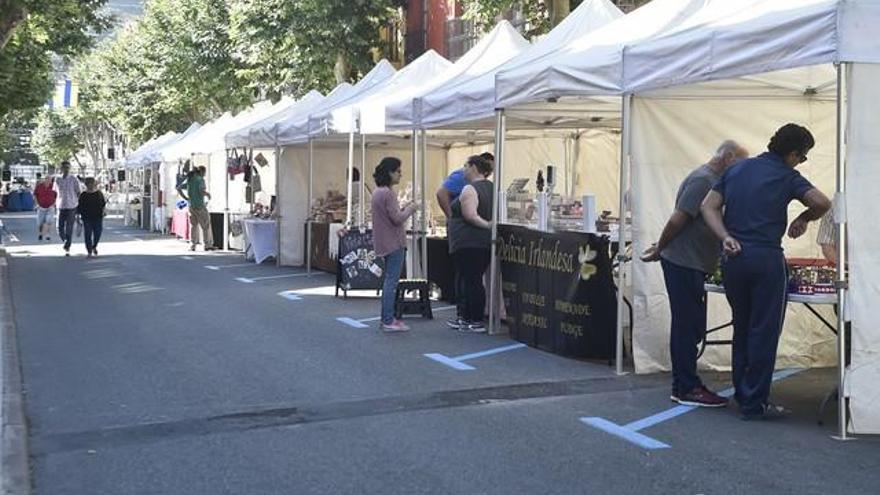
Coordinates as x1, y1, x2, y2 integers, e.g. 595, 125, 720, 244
701, 124, 831, 419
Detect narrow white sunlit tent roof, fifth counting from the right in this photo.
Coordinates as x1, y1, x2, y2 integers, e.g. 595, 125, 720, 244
326, 50, 452, 133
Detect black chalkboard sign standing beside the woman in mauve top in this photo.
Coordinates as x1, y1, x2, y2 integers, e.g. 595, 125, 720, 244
336, 230, 385, 292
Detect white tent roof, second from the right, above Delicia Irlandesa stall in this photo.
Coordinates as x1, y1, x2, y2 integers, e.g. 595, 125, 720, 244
495, 0, 708, 109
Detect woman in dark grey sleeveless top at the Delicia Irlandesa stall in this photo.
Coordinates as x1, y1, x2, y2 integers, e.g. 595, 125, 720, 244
447, 155, 495, 332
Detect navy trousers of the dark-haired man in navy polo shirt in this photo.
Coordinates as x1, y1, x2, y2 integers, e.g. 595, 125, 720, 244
723, 247, 788, 414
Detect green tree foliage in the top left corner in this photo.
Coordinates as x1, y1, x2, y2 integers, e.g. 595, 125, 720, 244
0, 0, 108, 116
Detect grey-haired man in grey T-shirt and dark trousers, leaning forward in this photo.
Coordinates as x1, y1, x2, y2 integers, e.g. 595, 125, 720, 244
642, 141, 748, 407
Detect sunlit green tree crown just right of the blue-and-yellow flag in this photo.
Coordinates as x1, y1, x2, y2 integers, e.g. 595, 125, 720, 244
74, 0, 251, 147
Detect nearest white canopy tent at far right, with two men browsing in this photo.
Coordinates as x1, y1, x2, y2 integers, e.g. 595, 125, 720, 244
612, 0, 880, 437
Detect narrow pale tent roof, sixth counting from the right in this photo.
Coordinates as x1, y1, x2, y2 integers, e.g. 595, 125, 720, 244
277, 59, 396, 145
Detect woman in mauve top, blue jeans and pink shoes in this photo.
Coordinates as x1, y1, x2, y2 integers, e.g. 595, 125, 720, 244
370, 157, 417, 332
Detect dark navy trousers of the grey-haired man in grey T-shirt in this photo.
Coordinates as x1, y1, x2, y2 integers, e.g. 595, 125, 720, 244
660, 259, 706, 396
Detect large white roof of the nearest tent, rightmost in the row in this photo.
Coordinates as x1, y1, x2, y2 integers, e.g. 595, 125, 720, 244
624, 0, 880, 92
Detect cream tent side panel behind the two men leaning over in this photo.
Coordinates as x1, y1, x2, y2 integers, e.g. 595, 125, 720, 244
632, 91, 836, 373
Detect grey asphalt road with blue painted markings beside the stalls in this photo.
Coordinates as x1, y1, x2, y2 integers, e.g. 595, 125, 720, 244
0, 215, 880, 495
